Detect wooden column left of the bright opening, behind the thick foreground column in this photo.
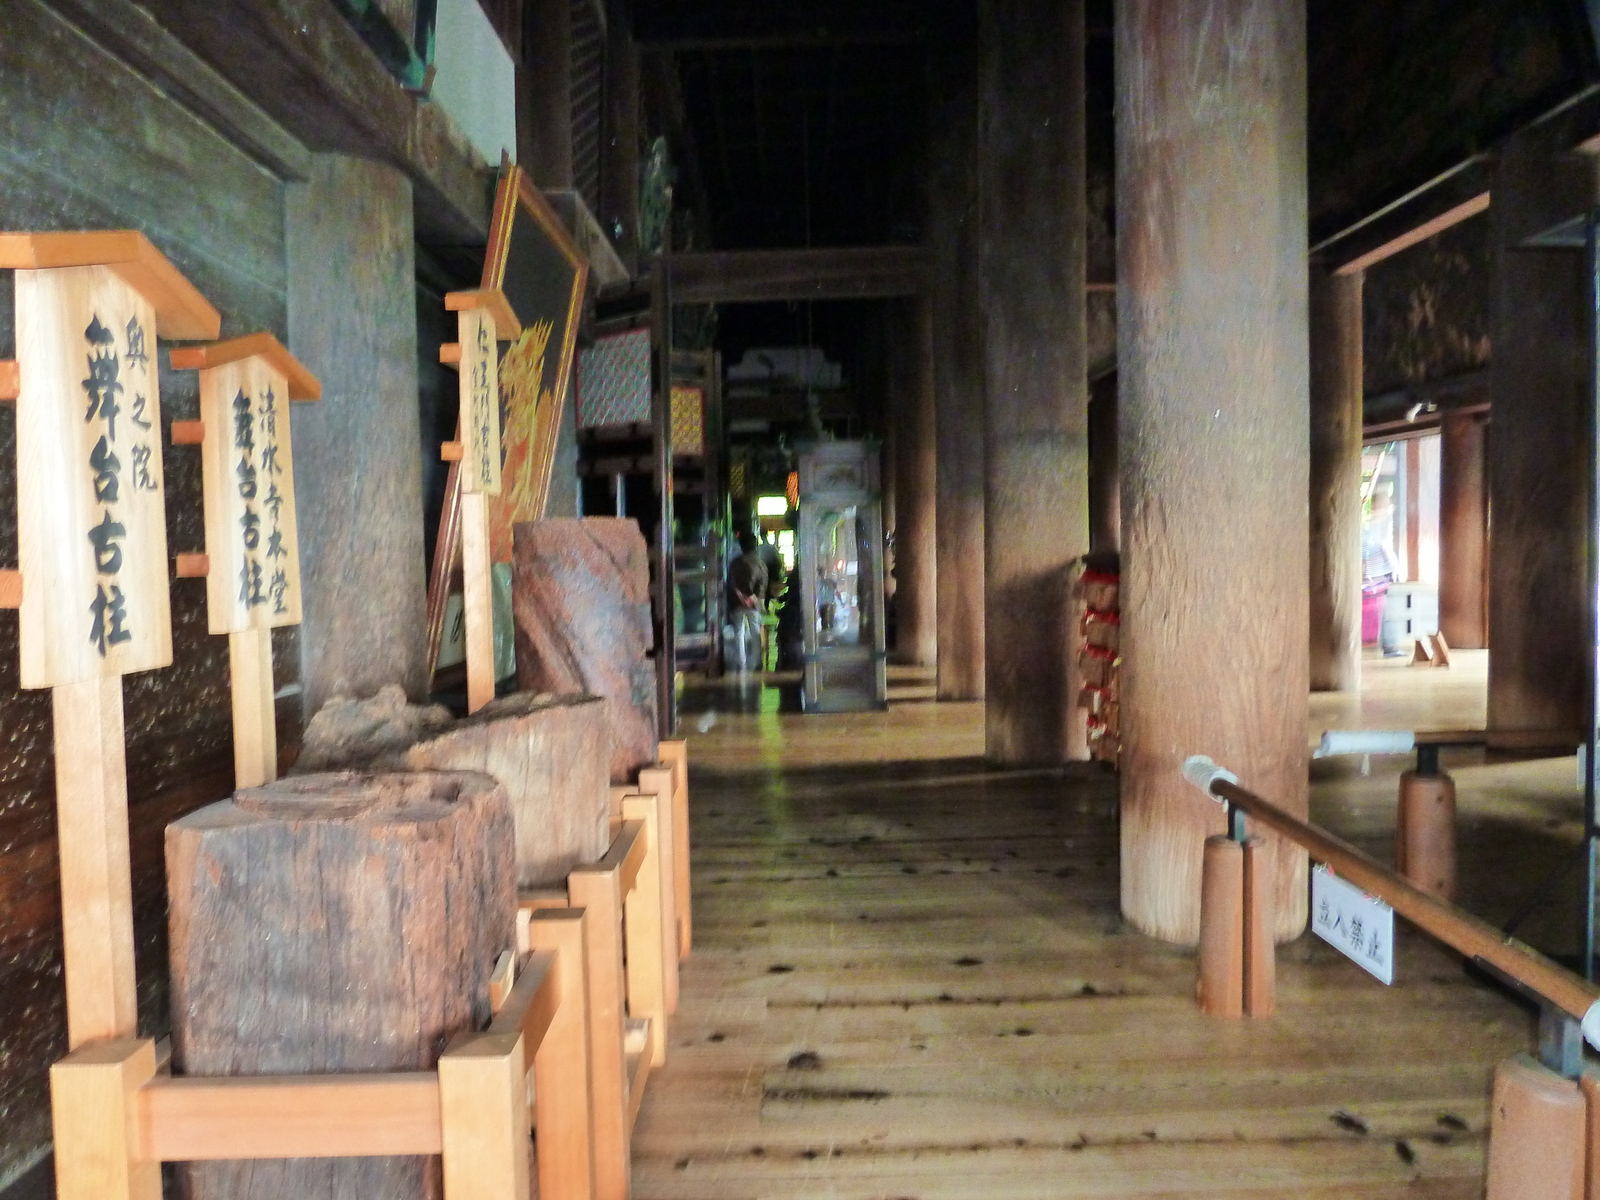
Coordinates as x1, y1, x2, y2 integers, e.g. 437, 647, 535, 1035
1310, 264, 1363, 691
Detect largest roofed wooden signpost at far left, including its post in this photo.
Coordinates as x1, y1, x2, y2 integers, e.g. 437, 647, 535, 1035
0, 230, 221, 1049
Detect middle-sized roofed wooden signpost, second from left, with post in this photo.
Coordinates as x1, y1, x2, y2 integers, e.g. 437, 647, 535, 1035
171, 333, 322, 787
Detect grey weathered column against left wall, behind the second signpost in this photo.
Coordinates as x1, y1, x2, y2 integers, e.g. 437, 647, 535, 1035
283, 154, 427, 717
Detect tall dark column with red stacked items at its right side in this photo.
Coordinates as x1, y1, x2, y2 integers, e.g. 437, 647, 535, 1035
978, 0, 1090, 765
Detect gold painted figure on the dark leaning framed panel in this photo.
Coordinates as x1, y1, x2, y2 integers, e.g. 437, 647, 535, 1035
490, 320, 560, 563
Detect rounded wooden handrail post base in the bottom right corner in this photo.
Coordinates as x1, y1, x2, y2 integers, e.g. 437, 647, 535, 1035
1486, 1054, 1594, 1200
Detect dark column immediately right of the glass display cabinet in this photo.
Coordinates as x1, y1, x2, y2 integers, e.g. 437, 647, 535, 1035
885, 299, 938, 667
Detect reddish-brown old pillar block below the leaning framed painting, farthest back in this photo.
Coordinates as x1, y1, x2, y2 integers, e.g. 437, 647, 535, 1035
512, 517, 658, 782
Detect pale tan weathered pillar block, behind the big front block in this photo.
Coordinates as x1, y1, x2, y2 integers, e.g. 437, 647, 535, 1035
405, 693, 611, 888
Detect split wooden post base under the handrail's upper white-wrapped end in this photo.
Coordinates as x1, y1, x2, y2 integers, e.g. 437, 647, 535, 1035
1195, 834, 1277, 1019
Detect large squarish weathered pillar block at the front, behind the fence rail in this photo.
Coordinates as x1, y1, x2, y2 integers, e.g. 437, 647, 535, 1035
166, 773, 517, 1200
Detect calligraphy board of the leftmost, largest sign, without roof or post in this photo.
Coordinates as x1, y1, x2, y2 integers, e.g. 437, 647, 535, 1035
16, 266, 173, 688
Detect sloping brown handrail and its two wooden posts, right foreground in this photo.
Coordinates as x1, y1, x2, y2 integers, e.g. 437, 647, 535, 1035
1184, 755, 1600, 1200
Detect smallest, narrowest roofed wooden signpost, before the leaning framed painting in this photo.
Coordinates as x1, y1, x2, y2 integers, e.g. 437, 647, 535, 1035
438, 290, 522, 712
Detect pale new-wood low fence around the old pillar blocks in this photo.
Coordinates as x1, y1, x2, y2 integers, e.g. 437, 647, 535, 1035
50, 746, 688, 1200
